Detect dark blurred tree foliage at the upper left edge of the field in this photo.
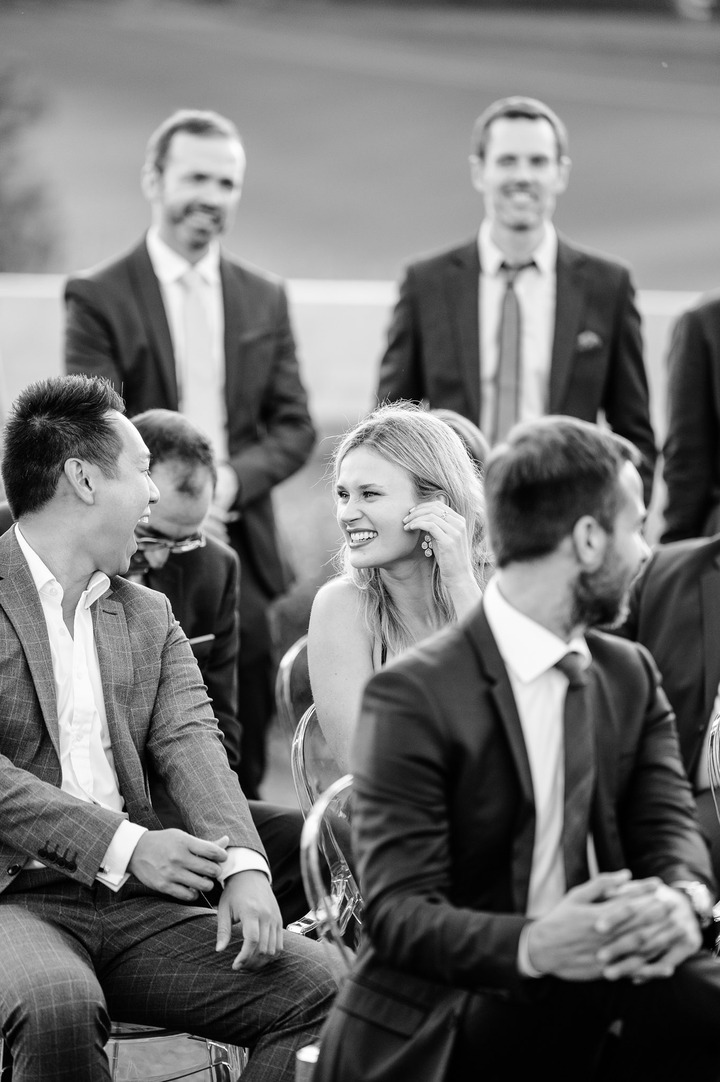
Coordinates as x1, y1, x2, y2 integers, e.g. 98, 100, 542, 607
0, 68, 58, 273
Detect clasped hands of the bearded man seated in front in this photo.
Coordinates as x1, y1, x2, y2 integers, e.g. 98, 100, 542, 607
527, 869, 702, 984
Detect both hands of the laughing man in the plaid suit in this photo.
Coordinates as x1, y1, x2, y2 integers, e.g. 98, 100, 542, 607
128, 829, 283, 969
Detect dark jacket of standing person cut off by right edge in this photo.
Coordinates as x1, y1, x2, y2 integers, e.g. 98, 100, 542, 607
660, 293, 720, 542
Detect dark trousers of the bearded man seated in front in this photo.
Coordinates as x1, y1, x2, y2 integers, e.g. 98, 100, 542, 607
447, 952, 720, 1082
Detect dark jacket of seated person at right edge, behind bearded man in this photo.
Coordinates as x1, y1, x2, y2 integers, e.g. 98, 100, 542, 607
617, 535, 720, 882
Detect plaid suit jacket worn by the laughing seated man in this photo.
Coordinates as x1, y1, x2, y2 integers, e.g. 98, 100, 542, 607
0, 531, 264, 892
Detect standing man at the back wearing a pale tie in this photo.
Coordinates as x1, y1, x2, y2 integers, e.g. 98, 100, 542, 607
65, 110, 314, 797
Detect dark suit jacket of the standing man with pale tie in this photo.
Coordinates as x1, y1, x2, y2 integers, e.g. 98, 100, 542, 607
65, 240, 314, 597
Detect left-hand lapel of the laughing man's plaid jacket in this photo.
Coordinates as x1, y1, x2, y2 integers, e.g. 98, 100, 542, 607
0, 530, 60, 762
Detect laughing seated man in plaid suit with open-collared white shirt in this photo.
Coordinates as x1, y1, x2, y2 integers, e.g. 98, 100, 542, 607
0, 377, 335, 1082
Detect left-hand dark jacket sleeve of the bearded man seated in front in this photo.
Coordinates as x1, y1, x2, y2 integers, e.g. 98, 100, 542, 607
351, 669, 526, 989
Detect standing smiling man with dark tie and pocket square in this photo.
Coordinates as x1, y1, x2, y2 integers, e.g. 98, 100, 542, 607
377, 97, 656, 504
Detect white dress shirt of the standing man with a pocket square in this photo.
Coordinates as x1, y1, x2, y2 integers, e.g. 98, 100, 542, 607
477, 219, 558, 441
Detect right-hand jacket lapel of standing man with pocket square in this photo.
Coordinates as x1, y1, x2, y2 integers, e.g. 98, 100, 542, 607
548, 238, 585, 413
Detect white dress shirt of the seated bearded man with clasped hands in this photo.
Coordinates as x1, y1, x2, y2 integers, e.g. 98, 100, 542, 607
483, 578, 597, 916
